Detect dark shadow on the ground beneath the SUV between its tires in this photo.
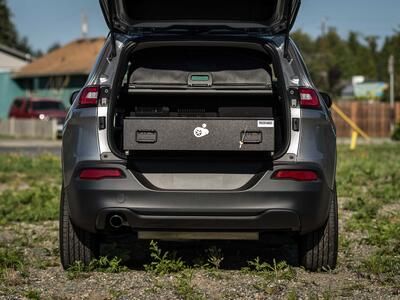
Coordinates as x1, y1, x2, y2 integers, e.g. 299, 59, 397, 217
100, 237, 299, 270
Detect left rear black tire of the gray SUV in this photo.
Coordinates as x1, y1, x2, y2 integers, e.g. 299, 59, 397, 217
59, 189, 99, 269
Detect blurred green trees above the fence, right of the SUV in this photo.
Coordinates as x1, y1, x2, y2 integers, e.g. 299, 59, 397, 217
292, 28, 400, 98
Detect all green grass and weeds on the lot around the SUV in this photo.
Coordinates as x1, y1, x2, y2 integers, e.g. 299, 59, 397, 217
0, 144, 400, 299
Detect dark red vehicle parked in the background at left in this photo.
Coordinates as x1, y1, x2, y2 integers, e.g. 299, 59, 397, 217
8, 98, 67, 138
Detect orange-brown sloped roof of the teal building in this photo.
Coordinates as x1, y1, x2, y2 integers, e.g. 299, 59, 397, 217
15, 38, 105, 78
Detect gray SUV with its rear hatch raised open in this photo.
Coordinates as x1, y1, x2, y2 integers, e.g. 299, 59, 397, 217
60, 0, 338, 271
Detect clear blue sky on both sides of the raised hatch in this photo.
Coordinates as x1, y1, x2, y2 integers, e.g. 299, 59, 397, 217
8, 0, 400, 51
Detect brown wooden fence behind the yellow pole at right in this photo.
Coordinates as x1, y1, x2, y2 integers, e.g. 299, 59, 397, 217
332, 101, 400, 138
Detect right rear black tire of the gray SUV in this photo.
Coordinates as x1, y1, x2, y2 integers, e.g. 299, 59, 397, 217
299, 185, 339, 272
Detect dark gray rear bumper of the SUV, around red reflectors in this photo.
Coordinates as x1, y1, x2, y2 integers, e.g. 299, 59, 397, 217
65, 164, 332, 233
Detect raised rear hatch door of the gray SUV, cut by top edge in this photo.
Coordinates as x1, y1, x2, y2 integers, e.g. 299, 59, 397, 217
100, 0, 301, 35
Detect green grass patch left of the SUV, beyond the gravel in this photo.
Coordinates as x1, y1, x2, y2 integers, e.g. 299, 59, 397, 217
0, 155, 61, 224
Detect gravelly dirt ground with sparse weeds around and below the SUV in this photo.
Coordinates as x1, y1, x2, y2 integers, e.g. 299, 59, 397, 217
0, 212, 400, 299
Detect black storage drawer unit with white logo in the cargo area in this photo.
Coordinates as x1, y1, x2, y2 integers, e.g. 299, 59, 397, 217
123, 117, 275, 152
